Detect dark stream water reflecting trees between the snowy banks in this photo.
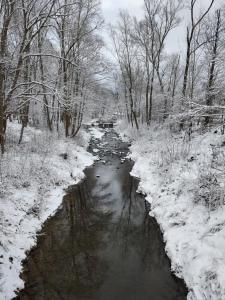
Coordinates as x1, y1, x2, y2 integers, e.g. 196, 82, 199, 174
17, 130, 187, 300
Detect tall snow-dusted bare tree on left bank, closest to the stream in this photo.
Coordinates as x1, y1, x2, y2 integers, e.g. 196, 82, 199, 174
55, 0, 102, 136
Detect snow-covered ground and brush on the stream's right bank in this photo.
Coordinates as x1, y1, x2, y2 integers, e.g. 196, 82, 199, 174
117, 120, 225, 300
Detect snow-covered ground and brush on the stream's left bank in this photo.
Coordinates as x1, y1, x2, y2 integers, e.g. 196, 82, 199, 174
0, 123, 96, 300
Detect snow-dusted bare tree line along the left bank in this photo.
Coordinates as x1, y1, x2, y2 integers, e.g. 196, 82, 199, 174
0, 0, 106, 153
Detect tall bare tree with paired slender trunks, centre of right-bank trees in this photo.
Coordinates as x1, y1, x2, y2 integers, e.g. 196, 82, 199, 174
135, 0, 180, 124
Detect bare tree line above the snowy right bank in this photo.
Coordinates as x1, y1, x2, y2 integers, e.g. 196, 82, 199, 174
110, 0, 225, 129
